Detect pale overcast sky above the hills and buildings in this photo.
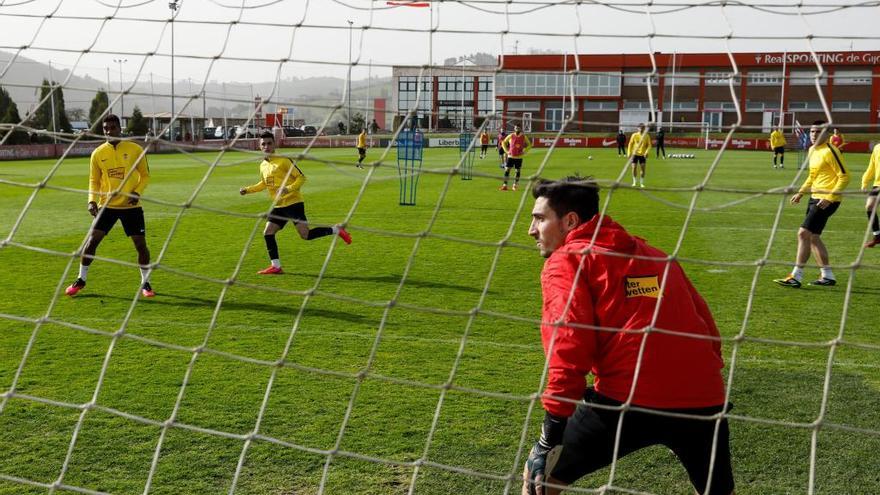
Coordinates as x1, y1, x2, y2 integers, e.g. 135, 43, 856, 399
0, 0, 880, 90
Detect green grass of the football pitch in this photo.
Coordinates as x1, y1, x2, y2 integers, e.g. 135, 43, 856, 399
0, 144, 880, 494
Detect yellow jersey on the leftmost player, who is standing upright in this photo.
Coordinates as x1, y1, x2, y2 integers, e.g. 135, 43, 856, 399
89, 141, 150, 209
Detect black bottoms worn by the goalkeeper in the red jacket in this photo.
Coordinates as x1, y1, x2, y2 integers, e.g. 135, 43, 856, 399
552, 389, 734, 495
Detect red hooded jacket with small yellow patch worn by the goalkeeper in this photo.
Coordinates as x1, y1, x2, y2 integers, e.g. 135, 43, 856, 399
541, 215, 725, 417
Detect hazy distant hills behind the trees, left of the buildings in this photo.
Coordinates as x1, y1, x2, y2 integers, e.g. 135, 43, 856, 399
0, 51, 391, 122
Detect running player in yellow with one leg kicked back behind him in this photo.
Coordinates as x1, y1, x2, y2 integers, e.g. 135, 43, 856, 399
238, 132, 351, 275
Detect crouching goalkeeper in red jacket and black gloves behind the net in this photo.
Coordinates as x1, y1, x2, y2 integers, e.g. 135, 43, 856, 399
523, 177, 734, 495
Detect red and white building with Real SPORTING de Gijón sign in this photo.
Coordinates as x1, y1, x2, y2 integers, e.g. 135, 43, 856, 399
392, 51, 880, 132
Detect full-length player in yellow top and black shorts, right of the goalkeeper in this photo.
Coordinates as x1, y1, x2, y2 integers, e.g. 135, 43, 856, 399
774, 120, 849, 288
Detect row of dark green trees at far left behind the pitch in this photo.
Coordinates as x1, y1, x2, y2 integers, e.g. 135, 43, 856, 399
0, 79, 149, 144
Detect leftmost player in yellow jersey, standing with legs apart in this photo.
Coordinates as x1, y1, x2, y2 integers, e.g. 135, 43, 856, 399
64, 114, 155, 297
